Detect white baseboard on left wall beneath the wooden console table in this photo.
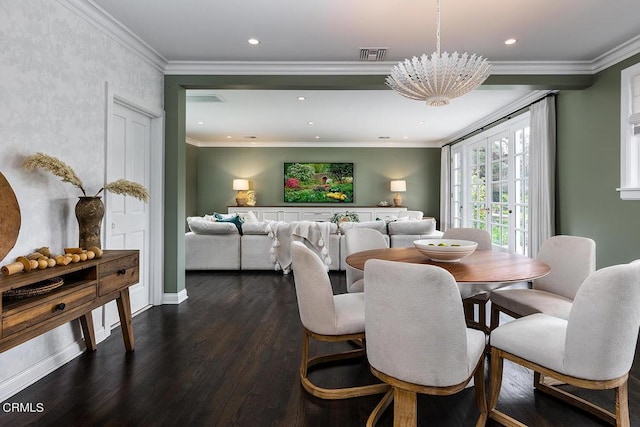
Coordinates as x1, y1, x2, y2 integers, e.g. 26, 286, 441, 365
0, 339, 85, 402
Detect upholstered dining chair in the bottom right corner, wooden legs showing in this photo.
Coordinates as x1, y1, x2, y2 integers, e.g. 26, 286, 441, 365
489, 263, 640, 426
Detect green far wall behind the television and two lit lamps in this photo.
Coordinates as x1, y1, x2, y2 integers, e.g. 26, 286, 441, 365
188, 147, 440, 222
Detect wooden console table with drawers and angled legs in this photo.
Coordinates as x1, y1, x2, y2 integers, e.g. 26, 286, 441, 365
0, 250, 140, 352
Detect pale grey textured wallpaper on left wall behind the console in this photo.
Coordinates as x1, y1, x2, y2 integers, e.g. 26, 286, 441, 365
0, 0, 163, 400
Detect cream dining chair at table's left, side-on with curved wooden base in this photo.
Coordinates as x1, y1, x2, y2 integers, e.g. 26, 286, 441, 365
291, 242, 389, 399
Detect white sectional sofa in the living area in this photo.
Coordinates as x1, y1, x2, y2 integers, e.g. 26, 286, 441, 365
185, 213, 442, 270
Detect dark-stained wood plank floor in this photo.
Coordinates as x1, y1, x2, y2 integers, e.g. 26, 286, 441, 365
0, 272, 640, 427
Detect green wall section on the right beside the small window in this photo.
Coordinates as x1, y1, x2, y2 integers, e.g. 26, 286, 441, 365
556, 55, 640, 268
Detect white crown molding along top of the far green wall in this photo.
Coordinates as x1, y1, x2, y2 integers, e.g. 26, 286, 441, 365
185, 137, 442, 148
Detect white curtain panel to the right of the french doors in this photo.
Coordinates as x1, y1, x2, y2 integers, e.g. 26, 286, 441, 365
529, 96, 556, 256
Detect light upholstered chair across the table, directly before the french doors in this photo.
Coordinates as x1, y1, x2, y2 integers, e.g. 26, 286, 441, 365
442, 227, 493, 332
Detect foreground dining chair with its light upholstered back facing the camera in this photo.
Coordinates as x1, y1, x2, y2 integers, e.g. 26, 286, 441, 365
364, 259, 487, 426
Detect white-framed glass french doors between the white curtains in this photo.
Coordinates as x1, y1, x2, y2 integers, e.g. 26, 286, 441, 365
450, 113, 529, 255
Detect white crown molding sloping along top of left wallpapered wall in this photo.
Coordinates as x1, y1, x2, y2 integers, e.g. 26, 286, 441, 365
58, 0, 168, 72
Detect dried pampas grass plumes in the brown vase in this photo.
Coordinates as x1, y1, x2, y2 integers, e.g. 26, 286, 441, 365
22, 153, 149, 203
